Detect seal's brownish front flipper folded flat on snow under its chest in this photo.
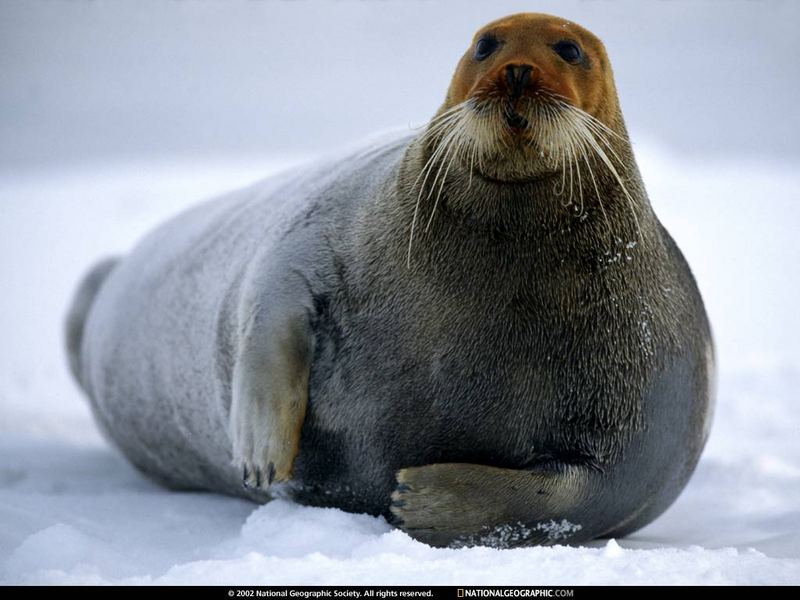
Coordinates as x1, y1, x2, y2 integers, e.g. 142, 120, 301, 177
391, 463, 607, 548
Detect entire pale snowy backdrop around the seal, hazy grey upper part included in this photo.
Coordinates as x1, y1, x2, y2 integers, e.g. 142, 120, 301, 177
0, 0, 800, 585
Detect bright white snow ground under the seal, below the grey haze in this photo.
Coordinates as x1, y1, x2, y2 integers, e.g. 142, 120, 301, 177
0, 145, 800, 585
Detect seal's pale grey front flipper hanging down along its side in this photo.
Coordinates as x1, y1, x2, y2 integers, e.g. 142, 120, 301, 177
230, 263, 313, 488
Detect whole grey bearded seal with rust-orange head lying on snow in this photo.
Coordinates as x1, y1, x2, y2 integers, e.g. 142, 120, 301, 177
67, 14, 713, 547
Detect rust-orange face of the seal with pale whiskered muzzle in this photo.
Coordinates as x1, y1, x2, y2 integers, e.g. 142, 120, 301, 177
432, 14, 621, 181
